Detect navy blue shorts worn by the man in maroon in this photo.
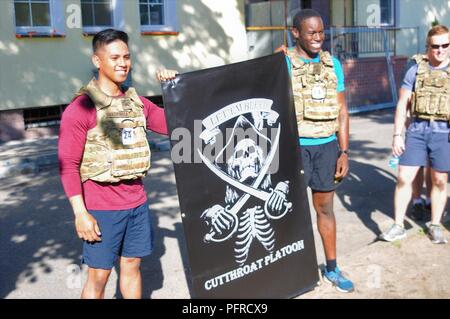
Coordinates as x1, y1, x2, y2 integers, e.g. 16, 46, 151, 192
82, 202, 153, 269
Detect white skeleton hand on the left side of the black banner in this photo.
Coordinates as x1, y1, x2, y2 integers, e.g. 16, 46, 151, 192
200, 205, 237, 243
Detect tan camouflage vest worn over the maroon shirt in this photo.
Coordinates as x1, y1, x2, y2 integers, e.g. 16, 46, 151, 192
76, 79, 150, 183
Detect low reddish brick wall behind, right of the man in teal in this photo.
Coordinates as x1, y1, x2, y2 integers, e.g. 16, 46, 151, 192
342, 56, 407, 107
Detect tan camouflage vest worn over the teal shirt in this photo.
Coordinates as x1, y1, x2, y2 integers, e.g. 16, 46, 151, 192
287, 50, 340, 138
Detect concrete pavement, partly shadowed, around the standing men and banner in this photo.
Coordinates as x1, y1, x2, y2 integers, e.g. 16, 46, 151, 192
0, 110, 450, 298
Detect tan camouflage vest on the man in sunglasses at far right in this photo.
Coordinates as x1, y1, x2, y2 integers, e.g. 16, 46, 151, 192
411, 54, 450, 121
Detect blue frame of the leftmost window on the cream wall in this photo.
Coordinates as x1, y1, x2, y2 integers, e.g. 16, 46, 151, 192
12, 0, 65, 37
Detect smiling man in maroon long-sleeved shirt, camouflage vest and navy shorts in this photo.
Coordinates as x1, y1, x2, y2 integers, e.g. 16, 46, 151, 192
58, 29, 176, 298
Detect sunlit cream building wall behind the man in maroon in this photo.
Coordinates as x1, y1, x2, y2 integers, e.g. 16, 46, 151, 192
0, 0, 248, 111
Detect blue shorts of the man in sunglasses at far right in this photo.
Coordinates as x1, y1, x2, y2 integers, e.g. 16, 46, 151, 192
399, 119, 450, 172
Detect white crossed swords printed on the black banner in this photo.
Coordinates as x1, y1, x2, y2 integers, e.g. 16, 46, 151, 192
197, 124, 292, 242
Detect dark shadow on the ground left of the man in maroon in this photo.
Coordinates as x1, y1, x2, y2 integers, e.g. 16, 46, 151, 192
0, 169, 81, 298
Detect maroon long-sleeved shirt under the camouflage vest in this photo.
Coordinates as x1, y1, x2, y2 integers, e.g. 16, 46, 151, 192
58, 95, 168, 210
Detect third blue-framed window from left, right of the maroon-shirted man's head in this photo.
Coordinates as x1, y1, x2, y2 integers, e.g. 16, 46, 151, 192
139, 0, 177, 33
